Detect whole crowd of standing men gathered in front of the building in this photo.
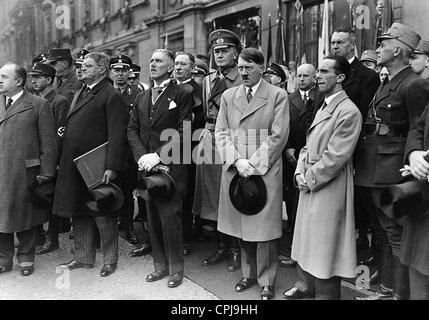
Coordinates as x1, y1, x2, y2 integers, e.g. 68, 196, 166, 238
0, 23, 429, 300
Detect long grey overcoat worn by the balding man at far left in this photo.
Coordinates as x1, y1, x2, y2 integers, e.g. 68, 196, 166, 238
0, 91, 57, 233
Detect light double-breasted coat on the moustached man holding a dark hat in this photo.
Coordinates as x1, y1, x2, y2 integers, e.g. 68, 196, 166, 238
215, 80, 289, 242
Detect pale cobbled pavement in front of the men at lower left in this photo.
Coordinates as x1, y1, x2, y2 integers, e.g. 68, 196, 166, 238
0, 234, 219, 300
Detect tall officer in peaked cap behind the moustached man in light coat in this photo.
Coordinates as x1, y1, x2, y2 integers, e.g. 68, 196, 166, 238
192, 29, 242, 271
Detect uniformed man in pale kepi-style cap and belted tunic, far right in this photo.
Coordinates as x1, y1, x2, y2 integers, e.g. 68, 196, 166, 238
354, 23, 428, 300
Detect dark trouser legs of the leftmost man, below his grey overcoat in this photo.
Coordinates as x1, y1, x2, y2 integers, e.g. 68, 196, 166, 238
0, 226, 40, 268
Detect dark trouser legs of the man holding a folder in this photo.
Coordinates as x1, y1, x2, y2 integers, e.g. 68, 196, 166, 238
73, 216, 118, 264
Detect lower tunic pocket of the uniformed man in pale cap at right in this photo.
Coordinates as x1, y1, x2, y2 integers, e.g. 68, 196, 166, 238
374, 140, 405, 184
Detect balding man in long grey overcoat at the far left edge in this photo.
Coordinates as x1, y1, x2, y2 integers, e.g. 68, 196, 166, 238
0, 63, 57, 276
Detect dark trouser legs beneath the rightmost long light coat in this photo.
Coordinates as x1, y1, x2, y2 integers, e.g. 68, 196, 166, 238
295, 264, 341, 300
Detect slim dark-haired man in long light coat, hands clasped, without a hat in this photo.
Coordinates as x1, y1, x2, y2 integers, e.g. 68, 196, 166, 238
283, 56, 362, 300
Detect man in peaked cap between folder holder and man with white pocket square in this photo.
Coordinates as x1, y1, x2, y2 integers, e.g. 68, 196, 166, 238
110, 54, 143, 244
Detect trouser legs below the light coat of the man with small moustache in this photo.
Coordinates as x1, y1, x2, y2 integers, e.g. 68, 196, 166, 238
239, 239, 278, 287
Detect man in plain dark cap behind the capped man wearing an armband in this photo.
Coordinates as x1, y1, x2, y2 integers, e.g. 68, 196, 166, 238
46, 49, 82, 103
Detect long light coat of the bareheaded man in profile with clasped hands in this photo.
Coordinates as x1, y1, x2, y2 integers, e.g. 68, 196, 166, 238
292, 91, 362, 279
